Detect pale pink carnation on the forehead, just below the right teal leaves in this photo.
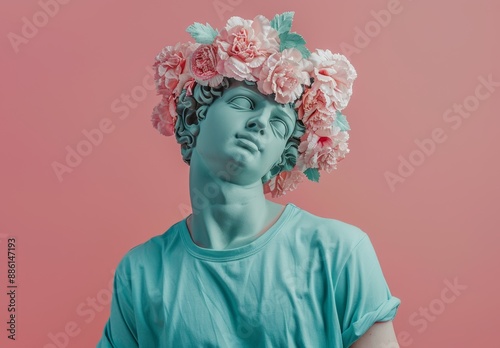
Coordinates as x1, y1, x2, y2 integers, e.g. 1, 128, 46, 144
257, 48, 311, 104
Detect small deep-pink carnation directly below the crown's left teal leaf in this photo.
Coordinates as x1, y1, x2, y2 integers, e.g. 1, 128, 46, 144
189, 45, 223, 87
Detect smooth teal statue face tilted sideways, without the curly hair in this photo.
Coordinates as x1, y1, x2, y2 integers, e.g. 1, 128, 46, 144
193, 81, 297, 185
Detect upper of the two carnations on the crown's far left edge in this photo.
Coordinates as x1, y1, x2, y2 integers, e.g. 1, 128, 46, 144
153, 42, 197, 97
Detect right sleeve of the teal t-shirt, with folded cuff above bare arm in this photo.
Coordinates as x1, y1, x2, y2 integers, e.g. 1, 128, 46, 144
335, 233, 401, 348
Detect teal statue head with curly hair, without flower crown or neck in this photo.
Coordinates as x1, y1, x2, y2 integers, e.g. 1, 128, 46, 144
175, 78, 305, 185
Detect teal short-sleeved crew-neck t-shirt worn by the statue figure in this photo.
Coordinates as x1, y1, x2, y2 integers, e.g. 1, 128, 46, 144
97, 203, 401, 348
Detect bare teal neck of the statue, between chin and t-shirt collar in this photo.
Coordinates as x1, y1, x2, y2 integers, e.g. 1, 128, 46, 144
188, 152, 282, 250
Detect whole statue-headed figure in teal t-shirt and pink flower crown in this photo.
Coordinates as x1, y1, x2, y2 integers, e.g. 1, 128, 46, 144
98, 12, 400, 348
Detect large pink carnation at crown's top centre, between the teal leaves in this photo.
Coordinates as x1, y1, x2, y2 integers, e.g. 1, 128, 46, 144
215, 15, 280, 81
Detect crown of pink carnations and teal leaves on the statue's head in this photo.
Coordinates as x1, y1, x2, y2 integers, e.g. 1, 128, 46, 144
152, 12, 357, 197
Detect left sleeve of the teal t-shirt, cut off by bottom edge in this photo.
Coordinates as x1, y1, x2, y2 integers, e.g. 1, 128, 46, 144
96, 253, 139, 348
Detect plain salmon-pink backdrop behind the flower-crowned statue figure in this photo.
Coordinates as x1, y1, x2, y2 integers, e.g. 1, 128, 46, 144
0, 0, 500, 348
